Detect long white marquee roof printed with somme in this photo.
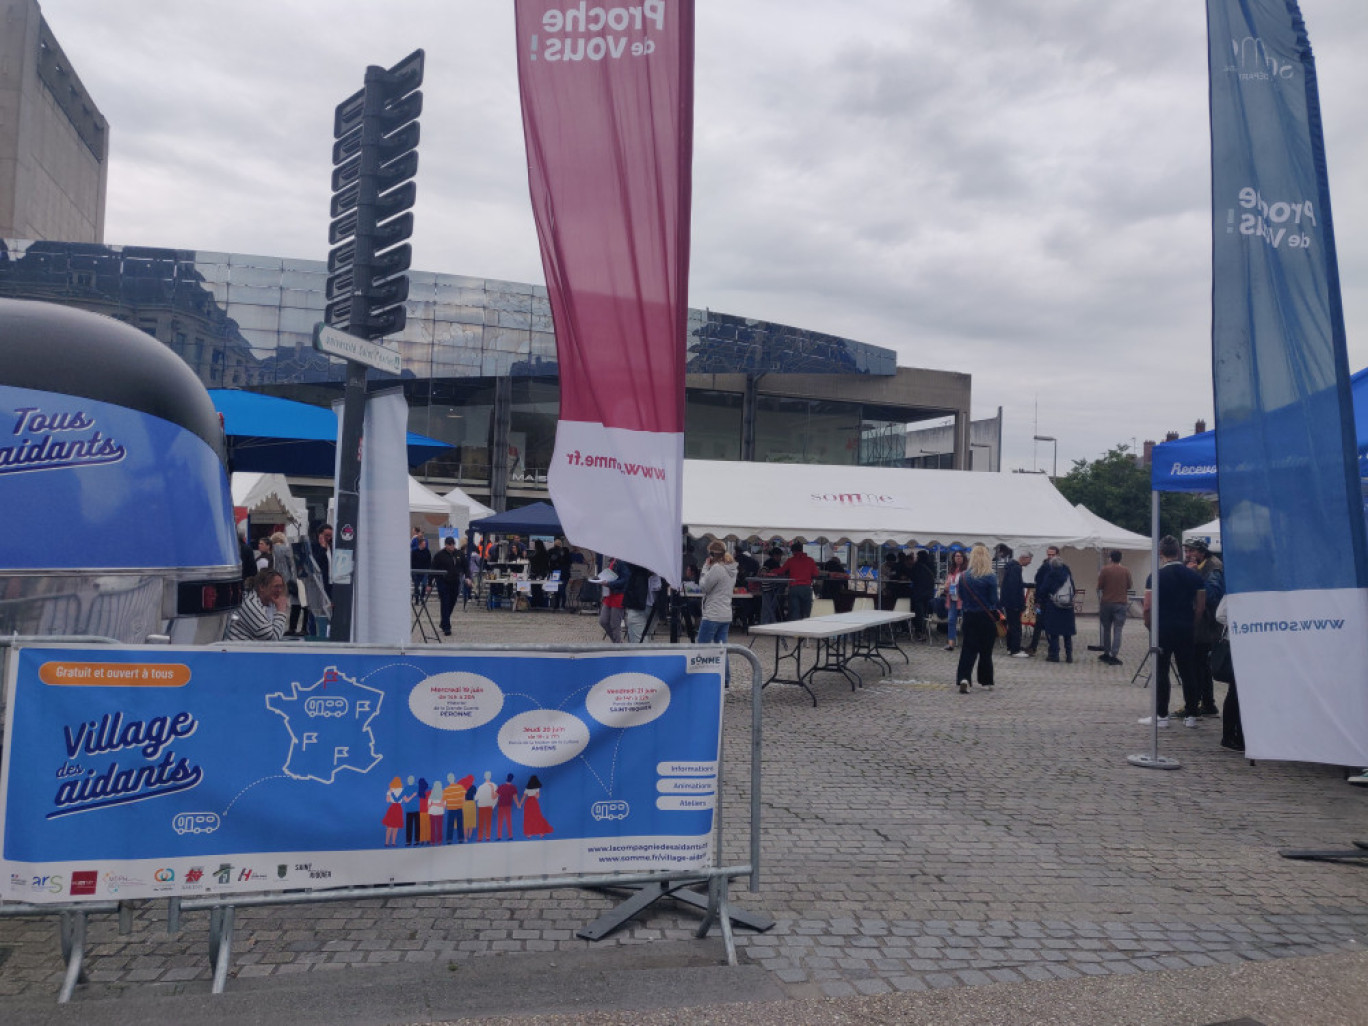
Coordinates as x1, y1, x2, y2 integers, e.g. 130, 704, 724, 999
683, 460, 1099, 547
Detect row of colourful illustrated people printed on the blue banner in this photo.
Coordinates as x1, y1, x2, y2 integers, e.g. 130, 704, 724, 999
382, 770, 551, 848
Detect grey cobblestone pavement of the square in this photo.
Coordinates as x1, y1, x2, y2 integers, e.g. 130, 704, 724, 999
0, 606, 1368, 1011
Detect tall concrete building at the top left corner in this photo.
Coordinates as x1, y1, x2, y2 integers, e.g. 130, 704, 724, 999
0, 0, 109, 242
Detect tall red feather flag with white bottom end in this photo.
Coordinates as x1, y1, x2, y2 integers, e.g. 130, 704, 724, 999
516, 0, 694, 586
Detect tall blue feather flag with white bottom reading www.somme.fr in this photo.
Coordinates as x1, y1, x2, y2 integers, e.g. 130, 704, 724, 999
1207, 0, 1368, 766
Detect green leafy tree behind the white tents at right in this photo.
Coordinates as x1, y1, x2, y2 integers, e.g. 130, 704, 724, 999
1055, 445, 1215, 538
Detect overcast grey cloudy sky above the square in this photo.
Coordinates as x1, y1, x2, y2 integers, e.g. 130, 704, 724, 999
32, 0, 1368, 471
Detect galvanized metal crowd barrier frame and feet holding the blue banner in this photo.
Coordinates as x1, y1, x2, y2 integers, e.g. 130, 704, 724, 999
0, 636, 774, 1004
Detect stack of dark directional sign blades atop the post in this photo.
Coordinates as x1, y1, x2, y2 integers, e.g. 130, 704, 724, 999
324, 49, 423, 338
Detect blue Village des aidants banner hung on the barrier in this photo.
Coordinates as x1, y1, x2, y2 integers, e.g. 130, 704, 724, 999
0, 646, 722, 902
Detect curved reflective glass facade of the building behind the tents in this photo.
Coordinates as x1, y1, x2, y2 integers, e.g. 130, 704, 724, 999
0, 239, 967, 505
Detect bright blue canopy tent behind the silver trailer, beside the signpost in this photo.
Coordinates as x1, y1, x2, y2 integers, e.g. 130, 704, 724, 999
209, 389, 451, 477
